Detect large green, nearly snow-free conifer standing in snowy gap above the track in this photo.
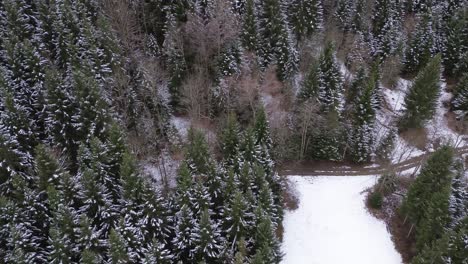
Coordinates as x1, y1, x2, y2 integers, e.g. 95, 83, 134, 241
398, 54, 441, 130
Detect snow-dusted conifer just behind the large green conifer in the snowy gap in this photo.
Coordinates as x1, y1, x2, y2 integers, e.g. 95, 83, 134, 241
405, 12, 435, 74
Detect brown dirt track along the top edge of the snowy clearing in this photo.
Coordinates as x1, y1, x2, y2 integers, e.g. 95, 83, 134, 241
279, 146, 468, 176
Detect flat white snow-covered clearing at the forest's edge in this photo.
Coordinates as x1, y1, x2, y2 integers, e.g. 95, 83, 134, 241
282, 176, 402, 264
